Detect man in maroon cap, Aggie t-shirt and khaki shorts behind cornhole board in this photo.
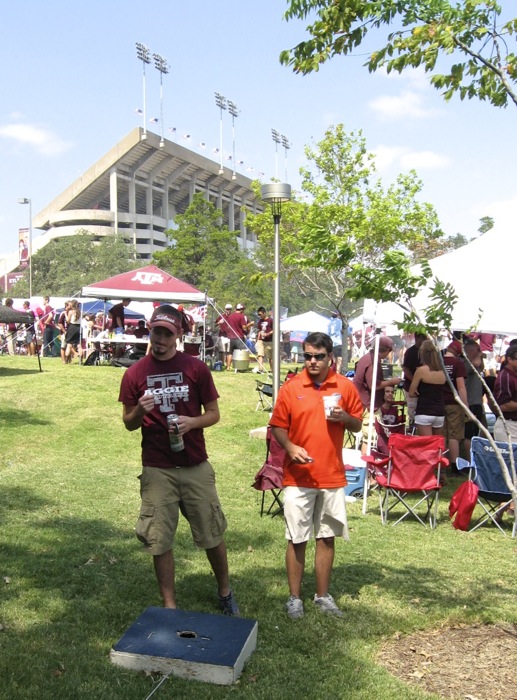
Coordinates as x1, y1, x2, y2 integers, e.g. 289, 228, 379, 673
119, 305, 239, 615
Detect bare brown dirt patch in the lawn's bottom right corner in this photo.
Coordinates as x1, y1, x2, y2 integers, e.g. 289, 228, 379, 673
377, 625, 517, 700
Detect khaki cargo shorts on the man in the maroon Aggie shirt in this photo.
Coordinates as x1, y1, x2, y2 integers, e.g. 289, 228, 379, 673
136, 462, 226, 556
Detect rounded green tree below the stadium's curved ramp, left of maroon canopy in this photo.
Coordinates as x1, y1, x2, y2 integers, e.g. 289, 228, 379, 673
12, 229, 138, 297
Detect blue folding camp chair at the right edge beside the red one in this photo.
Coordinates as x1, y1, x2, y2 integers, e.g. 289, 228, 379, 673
456, 437, 517, 537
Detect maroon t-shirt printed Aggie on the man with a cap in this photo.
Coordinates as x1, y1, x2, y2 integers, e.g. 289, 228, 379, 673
119, 352, 219, 468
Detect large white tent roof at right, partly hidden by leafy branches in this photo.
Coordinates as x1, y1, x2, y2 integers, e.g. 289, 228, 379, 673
364, 226, 517, 334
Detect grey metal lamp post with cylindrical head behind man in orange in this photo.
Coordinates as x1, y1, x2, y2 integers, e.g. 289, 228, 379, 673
260, 182, 291, 405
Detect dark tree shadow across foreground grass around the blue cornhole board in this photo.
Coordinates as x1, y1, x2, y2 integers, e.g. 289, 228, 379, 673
0, 488, 512, 700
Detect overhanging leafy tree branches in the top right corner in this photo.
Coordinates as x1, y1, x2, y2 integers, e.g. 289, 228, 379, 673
280, 0, 517, 107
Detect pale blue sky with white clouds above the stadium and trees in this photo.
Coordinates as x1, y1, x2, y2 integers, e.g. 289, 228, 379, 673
0, 0, 517, 260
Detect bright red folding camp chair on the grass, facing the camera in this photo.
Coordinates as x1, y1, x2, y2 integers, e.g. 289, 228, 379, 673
363, 433, 449, 528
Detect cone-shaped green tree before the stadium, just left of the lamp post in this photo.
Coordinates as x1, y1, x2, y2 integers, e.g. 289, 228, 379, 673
153, 193, 268, 306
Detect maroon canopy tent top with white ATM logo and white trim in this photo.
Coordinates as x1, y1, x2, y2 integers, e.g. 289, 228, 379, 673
82, 265, 205, 303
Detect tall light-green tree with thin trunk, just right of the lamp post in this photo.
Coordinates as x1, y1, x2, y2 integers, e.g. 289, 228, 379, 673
248, 124, 443, 367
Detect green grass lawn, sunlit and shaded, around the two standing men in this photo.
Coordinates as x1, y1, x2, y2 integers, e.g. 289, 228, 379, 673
0, 356, 517, 700
